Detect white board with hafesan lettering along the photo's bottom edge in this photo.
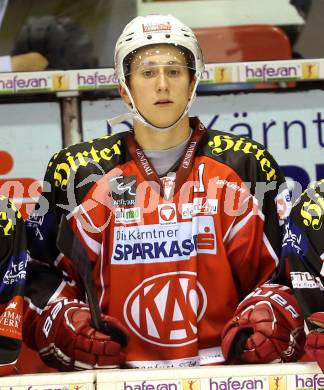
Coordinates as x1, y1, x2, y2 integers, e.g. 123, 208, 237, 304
0, 363, 324, 390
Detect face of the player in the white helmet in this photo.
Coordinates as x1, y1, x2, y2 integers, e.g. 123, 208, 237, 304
120, 45, 194, 128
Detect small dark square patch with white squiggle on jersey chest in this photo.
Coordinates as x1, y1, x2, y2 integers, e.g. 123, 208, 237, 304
109, 176, 137, 206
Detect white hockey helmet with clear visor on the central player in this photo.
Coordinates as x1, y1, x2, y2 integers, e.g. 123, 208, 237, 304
109, 15, 204, 130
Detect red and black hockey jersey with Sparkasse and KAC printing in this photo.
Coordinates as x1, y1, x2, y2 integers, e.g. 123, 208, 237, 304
24, 118, 289, 367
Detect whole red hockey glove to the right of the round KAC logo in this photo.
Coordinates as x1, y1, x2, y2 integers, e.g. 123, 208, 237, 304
222, 284, 305, 364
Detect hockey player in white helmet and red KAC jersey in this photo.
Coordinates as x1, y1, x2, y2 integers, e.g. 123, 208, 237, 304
25, 15, 304, 370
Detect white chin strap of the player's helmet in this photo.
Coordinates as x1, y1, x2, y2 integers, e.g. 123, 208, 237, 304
107, 75, 200, 132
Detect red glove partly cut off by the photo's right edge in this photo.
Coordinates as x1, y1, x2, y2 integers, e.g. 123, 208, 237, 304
305, 312, 324, 371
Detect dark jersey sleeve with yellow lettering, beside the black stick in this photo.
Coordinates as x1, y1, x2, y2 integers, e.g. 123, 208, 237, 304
26, 146, 107, 310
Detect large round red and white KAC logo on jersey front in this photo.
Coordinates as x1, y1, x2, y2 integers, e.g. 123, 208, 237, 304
124, 271, 207, 347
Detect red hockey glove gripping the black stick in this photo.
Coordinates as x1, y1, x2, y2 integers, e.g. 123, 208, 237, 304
36, 299, 128, 371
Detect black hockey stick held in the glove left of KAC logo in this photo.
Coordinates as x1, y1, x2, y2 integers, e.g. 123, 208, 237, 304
56, 215, 127, 347
